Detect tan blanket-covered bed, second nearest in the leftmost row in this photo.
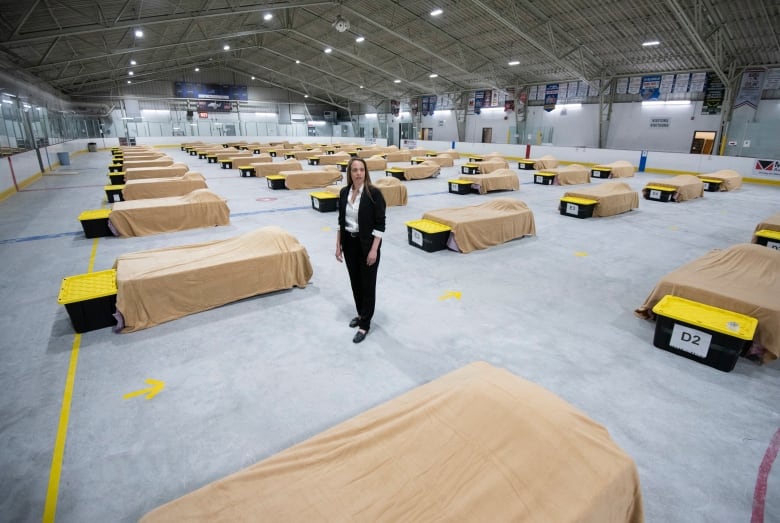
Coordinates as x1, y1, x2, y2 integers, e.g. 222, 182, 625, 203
108, 189, 230, 236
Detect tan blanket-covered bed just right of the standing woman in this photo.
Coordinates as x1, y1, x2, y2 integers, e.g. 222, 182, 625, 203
423, 198, 536, 253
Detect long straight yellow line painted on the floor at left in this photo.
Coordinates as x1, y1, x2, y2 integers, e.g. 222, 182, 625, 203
43, 238, 98, 523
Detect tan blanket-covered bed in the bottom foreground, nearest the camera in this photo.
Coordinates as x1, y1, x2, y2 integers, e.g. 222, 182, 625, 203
141, 362, 644, 523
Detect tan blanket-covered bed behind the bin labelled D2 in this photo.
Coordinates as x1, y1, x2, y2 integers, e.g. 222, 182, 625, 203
635, 243, 780, 363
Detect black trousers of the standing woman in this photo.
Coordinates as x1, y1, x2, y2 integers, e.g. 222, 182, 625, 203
341, 232, 382, 331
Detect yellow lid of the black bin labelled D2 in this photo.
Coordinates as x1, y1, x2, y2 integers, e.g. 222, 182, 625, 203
653, 294, 758, 340
